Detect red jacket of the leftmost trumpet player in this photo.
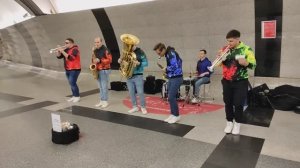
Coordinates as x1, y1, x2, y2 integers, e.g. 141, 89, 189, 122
57, 45, 81, 70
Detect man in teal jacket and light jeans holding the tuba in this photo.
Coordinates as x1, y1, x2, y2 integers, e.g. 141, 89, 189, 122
118, 45, 148, 114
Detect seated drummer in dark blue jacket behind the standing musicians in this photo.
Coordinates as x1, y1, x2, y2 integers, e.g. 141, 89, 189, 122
191, 49, 211, 103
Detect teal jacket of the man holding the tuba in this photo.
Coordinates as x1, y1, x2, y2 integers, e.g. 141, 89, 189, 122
133, 47, 148, 75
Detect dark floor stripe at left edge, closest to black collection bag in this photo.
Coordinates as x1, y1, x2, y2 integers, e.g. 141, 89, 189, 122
0, 101, 57, 118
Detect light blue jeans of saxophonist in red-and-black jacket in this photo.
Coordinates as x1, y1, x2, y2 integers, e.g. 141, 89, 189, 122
98, 69, 111, 101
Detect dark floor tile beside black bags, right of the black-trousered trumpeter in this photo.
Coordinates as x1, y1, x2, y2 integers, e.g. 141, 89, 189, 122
242, 107, 274, 127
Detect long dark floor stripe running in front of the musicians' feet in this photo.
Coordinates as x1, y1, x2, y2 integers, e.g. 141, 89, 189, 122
72, 106, 194, 137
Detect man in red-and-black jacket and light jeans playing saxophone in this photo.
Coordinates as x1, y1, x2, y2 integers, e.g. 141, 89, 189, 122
92, 37, 112, 108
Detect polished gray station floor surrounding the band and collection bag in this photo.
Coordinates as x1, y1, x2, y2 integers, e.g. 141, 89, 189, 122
0, 61, 300, 168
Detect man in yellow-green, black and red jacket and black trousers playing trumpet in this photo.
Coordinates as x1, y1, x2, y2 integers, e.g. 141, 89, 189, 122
222, 30, 256, 134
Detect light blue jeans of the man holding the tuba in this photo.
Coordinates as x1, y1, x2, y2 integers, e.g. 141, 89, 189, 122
126, 75, 146, 108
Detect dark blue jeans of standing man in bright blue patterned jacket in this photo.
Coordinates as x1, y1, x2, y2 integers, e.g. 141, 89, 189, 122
168, 77, 183, 116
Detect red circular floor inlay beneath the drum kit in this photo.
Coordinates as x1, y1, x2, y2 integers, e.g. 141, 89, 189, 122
123, 96, 224, 114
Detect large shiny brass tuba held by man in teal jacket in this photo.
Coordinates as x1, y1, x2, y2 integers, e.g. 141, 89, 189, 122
120, 34, 140, 79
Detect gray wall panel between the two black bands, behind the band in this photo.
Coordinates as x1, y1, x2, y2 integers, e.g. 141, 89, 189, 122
106, 0, 254, 73
